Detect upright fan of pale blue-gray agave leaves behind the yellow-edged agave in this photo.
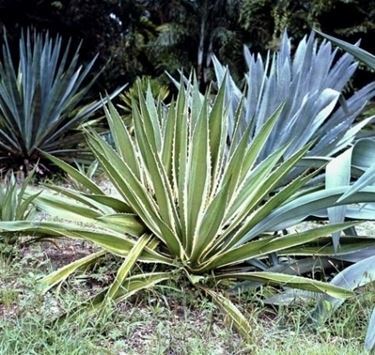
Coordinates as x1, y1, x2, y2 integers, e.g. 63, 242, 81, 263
213, 33, 375, 159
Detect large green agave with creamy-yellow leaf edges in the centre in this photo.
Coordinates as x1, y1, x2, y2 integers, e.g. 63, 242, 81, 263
0, 79, 375, 334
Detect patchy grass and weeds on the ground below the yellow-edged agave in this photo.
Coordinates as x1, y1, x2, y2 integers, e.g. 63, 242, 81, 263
0, 241, 375, 355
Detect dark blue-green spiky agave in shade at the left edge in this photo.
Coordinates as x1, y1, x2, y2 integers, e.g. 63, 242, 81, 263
0, 31, 122, 173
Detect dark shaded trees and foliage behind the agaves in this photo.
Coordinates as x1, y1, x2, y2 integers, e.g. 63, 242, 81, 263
0, 0, 375, 90
